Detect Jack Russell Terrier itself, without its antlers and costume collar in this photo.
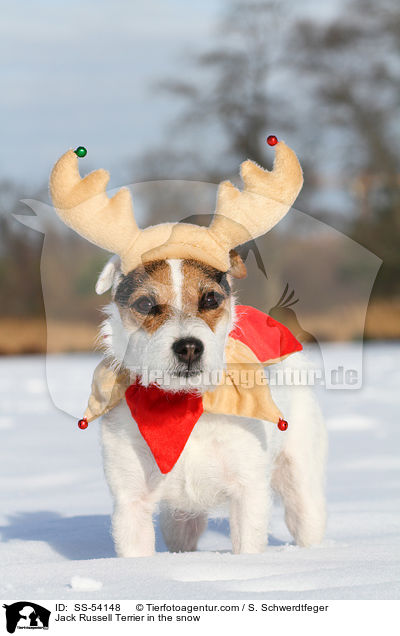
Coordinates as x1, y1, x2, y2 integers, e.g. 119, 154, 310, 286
96, 257, 327, 557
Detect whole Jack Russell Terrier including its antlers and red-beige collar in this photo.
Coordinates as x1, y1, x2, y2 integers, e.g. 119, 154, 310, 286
50, 135, 326, 557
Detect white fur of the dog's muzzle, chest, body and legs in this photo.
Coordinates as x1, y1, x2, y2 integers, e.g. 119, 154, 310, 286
97, 256, 326, 557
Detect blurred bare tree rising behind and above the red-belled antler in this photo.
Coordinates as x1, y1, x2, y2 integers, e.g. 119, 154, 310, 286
138, 0, 293, 180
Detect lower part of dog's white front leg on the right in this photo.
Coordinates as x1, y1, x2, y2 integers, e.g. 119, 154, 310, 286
230, 483, 271, 554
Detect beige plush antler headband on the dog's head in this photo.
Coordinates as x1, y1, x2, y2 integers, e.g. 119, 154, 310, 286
50, 141, 303, 274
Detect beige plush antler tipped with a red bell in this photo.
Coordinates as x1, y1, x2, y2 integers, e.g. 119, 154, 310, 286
210, 141, 303, 249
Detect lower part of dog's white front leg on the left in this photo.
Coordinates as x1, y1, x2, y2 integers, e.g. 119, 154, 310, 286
112, 499, 155, 557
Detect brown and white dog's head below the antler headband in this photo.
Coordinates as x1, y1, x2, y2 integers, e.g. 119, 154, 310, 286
96, 253, 246, 392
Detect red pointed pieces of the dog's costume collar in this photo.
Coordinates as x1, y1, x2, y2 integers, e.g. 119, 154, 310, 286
125, 305, 302, 474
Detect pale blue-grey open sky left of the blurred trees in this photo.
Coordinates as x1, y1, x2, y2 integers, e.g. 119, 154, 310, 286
0, 0, 340, 189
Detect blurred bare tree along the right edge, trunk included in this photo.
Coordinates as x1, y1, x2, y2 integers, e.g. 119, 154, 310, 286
293, 0, 400, 295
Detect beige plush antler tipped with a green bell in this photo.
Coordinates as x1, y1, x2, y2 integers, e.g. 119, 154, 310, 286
50, 150, 140, 258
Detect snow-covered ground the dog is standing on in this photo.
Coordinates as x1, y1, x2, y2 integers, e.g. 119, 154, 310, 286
0, 344, 400, 599
